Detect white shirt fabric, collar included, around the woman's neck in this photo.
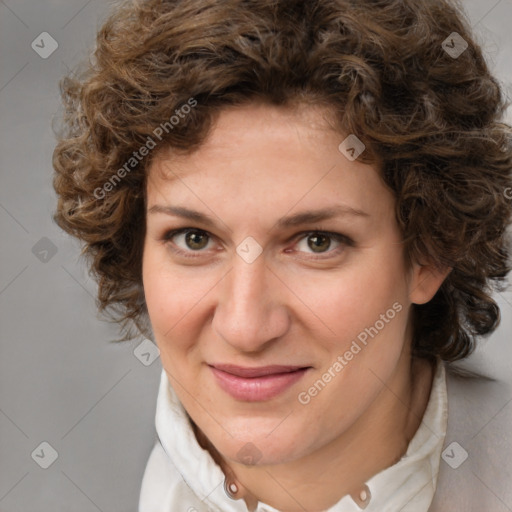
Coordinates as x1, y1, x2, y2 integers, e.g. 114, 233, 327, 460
139, 363, 447, 512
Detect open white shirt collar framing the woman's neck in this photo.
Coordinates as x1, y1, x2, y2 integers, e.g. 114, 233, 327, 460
155, 360, 448, 512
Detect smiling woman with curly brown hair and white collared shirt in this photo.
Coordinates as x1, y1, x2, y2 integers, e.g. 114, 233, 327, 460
54, 0, 512, 512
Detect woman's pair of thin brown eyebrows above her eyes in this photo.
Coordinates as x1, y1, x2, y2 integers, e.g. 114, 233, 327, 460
148, 204, 370, 229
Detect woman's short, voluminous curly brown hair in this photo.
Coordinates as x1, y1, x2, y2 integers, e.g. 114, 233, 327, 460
53, 0, 512, 361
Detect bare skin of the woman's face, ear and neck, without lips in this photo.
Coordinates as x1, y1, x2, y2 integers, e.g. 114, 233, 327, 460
143, 103, 446, 512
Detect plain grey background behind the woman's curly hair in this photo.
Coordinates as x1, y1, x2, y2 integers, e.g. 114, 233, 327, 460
0, 0, 512, 512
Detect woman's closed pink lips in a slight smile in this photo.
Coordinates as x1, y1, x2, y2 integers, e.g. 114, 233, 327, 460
210, 364, 309, 402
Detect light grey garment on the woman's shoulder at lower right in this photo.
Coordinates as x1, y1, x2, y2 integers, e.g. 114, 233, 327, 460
429, 360, 512, 512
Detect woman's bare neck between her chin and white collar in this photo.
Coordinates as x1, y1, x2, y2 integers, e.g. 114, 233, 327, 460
195, 352, 433, 512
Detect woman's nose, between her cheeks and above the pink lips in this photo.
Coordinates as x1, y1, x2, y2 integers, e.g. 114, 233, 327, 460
212, 255, 290, 353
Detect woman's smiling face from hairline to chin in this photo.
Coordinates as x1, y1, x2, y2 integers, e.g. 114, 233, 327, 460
143, 104, 432, 464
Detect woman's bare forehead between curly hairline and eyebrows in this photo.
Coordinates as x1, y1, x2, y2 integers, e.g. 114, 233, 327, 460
147, 104, 392, 223
